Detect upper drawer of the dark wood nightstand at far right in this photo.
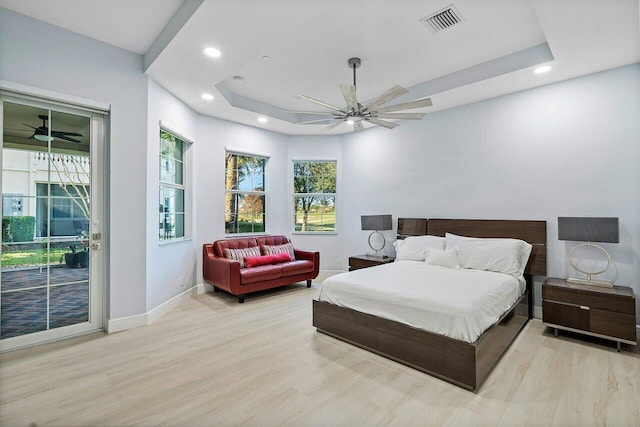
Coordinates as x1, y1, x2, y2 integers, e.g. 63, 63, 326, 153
542, 286, 636, 314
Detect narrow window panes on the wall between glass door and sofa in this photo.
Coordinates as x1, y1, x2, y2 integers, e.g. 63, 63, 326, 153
159, 129, 189, 240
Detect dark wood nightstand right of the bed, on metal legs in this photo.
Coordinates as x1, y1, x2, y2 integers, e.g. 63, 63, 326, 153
542, 277, 637, 351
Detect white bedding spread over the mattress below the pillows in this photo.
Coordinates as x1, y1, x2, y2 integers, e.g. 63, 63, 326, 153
319, 261, 525, 343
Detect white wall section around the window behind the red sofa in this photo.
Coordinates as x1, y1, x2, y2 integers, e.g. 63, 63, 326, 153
194, 116, 291, 283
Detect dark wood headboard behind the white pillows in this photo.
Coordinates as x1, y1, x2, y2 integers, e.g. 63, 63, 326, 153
398, 218, 547, 276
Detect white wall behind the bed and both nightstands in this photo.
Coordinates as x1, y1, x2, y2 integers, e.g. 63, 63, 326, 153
342, 64, 640, 313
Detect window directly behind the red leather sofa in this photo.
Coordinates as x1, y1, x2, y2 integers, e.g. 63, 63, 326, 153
224, 151, 267, 234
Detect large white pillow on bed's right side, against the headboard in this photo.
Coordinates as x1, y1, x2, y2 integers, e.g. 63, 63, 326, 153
445, 233, 532, 277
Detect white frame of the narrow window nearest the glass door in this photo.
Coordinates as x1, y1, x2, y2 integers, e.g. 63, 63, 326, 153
156, 121, 193, 245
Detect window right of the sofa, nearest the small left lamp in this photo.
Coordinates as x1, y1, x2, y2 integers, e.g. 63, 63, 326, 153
293, 160, 337, 232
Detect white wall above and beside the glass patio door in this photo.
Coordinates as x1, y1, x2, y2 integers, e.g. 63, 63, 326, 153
0, 8, 147, 318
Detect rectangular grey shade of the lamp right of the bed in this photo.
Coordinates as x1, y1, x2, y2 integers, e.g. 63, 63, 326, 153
558, 216, 619, 243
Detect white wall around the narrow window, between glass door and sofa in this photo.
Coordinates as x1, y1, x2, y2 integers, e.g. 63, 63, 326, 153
146, 79, 200, 311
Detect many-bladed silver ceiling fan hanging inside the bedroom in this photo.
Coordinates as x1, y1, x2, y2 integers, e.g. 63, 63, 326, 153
289, 58, 433, 132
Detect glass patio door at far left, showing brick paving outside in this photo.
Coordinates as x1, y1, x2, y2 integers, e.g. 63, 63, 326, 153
0, 100, 102, 349
